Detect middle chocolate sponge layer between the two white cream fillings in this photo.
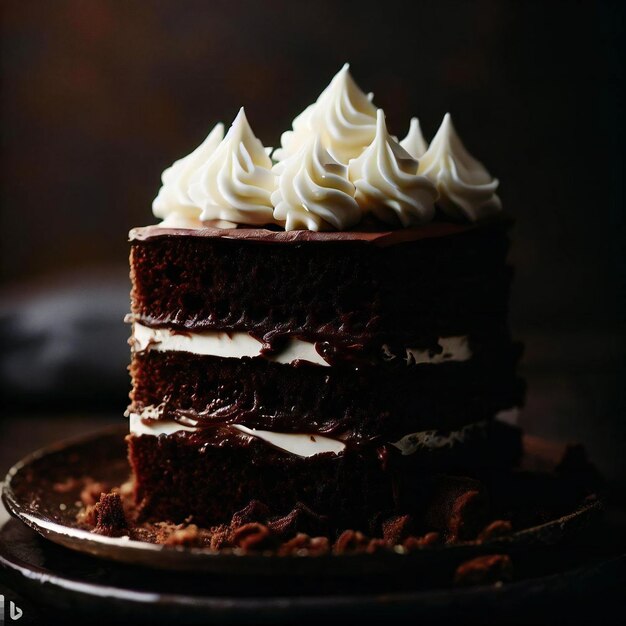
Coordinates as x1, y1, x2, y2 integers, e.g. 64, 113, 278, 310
130, 341, 523, 438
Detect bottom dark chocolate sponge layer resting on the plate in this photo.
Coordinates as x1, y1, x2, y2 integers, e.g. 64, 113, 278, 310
127, 422, 521, 532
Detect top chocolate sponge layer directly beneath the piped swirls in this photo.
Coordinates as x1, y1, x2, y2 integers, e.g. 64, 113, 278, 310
131, 221, 511, 347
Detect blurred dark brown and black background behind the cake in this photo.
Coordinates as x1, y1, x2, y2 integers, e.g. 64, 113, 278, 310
0, 0, 626, 484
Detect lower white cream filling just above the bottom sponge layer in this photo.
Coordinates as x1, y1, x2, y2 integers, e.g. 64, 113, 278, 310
129, 411, 346, 457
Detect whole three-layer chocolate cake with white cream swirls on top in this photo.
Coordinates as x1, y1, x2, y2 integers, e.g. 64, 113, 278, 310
123, 66, 523, 536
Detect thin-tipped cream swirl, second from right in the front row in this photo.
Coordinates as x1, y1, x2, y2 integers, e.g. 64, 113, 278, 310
348, 109, 437, 227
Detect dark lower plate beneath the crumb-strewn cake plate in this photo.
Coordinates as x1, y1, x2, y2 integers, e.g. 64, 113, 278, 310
0, 520, 626, 626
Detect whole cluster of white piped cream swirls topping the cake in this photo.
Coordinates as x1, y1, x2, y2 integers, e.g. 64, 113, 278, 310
152, 64, 501, 231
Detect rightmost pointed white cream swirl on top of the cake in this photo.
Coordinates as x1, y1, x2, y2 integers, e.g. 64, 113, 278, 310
419, 113, 502, 222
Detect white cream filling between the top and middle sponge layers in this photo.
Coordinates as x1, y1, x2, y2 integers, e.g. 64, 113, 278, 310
131, 322, 472, 367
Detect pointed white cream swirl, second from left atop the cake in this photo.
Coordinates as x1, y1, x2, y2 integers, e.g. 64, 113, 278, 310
189, 107, 276, 225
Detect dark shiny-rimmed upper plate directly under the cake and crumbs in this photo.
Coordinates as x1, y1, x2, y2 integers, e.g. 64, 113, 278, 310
2, 425, 600, 581
